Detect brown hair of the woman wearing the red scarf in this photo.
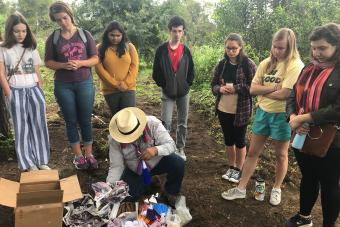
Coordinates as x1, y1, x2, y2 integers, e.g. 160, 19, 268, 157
309, 23, 340, 65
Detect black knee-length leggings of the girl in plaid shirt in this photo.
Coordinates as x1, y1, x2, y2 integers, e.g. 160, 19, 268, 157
217, 110, 247, 148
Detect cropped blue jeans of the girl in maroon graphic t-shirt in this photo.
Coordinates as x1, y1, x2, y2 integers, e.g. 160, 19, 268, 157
54, 76, 94, 145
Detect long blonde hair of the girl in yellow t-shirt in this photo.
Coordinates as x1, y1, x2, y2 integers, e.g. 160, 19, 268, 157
266, 28, 300, 73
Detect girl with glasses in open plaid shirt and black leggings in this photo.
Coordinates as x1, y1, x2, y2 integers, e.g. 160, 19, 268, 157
211, 33, 256, 183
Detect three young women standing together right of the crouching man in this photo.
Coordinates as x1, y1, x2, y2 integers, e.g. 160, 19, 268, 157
216, 23, 340, 227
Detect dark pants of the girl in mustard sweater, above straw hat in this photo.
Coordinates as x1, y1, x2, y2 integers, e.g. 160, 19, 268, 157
104, 91, 136, 116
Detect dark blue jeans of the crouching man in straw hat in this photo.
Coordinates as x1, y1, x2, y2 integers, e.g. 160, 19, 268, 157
121, 153, 184, 201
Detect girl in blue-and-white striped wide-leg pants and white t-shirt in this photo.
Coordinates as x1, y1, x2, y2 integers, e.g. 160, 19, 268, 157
0, 12, 50, 171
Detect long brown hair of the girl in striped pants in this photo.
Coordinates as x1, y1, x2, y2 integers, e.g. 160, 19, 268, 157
1, 12, 37, 49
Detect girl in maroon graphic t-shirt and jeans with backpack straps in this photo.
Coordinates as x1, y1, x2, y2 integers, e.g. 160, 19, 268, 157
45, 1, 98, 169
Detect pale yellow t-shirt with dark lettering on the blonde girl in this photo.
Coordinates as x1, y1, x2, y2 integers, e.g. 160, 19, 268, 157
252, 58, 304, 113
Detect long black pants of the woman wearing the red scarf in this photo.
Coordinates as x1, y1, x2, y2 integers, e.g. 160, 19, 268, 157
294, 149, 340, 227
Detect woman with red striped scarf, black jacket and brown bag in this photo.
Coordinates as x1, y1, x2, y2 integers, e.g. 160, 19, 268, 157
286, 23, 340, 227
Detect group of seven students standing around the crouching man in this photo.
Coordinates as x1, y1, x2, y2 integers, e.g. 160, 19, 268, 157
0, 1, 340, 227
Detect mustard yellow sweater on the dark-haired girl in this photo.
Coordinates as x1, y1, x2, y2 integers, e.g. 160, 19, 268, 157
95, 43, 138, 95
